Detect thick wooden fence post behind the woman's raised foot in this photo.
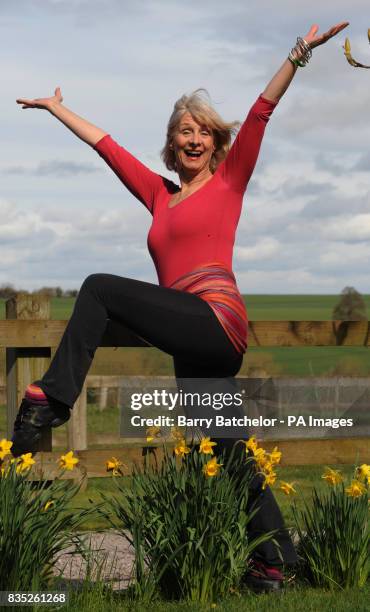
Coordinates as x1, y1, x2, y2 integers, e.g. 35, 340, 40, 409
5, 293, 52, 451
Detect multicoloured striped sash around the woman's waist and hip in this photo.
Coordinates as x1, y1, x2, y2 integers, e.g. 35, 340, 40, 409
170, 262, 248, 353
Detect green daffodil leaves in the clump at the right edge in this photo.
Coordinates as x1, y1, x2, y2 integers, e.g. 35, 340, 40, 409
293, 483, 370, 589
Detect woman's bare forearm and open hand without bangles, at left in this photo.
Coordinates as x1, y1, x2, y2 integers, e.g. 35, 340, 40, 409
17, 87, 106, 147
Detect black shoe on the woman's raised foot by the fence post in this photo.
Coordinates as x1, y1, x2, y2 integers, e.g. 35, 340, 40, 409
10, 398, 70, 457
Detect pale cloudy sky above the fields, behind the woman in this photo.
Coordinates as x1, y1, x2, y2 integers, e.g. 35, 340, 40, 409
0, 0, 370, 294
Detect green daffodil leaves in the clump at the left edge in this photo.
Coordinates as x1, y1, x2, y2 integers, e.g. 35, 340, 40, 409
0, 463, 92, 591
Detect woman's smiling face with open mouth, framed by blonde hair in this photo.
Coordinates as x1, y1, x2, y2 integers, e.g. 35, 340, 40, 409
172, 112, 215, 174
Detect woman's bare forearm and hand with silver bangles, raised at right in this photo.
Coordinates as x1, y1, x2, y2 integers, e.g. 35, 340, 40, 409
262, 21, 348, 102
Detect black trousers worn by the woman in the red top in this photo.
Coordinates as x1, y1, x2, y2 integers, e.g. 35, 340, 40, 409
38, 274, 296, 565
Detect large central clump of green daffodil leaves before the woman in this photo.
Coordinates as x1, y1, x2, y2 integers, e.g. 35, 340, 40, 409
101, 450, 272, 603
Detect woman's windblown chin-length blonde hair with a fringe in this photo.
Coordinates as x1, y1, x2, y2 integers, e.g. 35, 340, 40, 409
161, 88, 240, 173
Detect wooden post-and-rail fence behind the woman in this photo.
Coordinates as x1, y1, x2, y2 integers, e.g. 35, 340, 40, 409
0, 294, 370, 476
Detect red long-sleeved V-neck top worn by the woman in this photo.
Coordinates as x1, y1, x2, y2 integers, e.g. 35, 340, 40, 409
94, 96, 277, 287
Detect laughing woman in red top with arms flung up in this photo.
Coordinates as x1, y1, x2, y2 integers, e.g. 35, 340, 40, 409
12, 22, 348, 589
